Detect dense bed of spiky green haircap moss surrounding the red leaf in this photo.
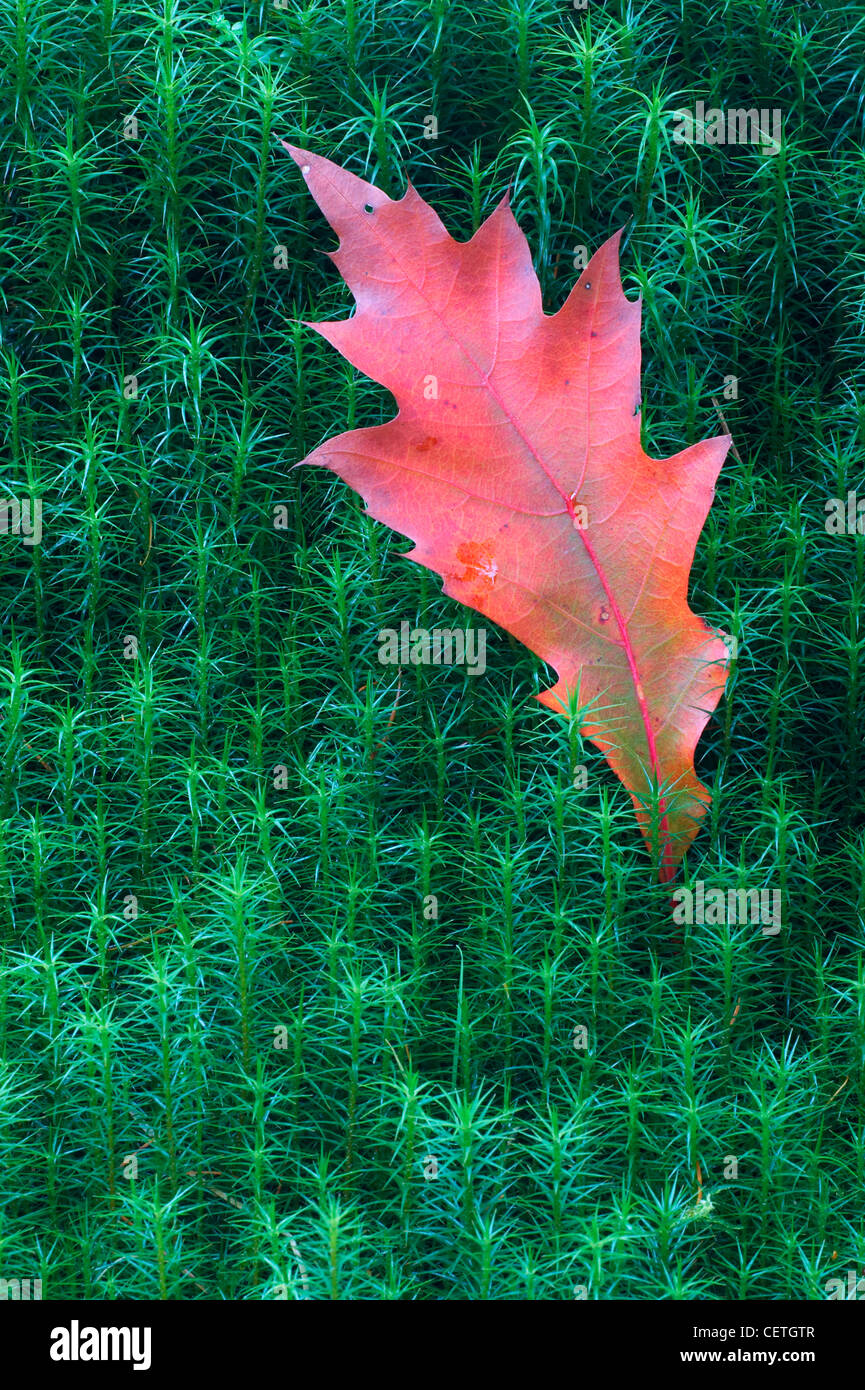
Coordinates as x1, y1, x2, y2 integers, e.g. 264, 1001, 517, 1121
0, 0, 865, 1300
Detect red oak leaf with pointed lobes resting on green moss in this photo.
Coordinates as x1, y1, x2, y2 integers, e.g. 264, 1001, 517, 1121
282, 142, 730, 881
